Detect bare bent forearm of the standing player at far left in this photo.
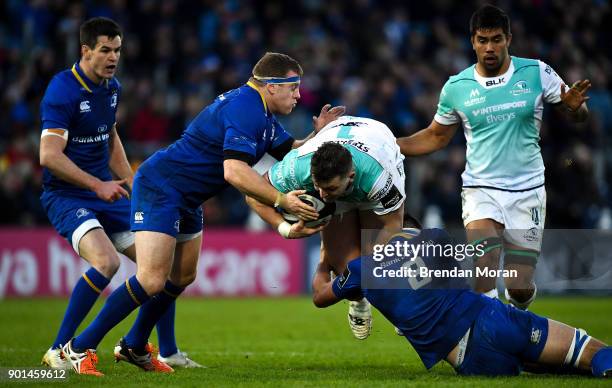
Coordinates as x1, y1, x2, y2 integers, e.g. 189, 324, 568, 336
39, 128, 128, 202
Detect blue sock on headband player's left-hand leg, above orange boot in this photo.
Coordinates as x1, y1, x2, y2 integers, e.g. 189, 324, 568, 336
72, 276, 149, 352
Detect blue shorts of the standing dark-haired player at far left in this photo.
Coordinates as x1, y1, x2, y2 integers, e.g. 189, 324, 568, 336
40, 191, 134, 254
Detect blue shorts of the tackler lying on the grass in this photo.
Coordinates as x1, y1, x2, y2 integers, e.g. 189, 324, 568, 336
456, 299, 548, 376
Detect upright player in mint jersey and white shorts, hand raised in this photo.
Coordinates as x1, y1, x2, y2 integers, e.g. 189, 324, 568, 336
398, 5, 591, 309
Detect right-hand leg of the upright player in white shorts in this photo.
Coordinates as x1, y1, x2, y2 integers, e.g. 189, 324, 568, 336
504, 186, 546, 309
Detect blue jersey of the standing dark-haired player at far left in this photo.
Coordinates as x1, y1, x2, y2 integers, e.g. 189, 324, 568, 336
40, 63, 121, 196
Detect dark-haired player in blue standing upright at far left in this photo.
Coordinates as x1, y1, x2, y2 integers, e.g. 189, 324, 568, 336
40, 18, 191, 369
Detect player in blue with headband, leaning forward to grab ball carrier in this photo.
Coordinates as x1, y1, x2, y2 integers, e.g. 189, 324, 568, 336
63, 53, 344, 375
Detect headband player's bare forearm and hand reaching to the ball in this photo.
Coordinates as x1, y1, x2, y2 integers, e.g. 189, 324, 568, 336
223, 159, 319, 220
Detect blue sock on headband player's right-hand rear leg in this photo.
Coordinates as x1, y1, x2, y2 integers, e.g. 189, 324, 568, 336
124, 280, 185, 354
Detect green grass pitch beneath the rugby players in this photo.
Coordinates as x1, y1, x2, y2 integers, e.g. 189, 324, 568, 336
0, 297, 612, 388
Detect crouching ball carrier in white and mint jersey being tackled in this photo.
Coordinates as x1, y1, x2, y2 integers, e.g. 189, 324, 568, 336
247, 116, 406, 339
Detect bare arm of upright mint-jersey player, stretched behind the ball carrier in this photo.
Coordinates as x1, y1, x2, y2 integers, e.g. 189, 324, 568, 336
396, 120, 459, 156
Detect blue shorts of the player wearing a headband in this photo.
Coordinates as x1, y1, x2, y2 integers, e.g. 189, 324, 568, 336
130, 171, 203, 241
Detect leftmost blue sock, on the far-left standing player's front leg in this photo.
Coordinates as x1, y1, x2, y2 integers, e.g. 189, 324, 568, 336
51, 267, 110, 349
